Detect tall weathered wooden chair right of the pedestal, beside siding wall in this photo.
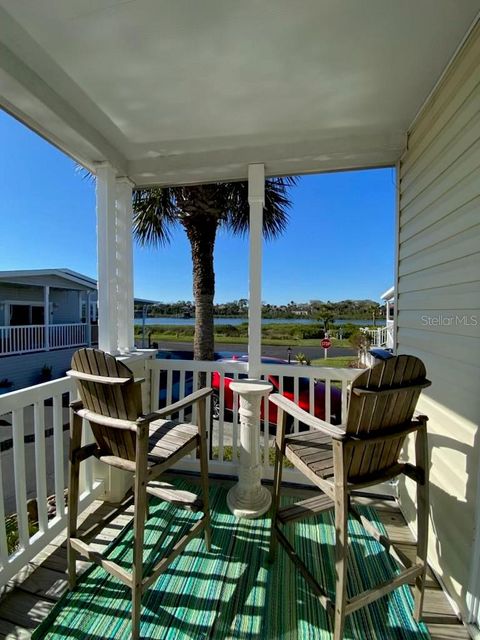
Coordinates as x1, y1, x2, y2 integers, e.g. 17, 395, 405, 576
270, 355, 431, 640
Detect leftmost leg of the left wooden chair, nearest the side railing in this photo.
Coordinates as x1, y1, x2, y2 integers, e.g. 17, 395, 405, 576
67, 412, 82, 589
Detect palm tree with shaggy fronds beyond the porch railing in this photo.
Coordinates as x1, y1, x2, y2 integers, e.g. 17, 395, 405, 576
133, 177, 296, 360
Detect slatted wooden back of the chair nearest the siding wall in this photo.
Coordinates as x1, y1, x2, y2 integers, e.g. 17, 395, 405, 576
346, 355, 430, 480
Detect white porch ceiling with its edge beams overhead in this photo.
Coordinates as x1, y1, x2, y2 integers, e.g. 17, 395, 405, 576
0, 0, 478, 185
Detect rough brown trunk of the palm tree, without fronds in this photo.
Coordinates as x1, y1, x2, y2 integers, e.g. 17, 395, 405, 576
183, 219, 218, 360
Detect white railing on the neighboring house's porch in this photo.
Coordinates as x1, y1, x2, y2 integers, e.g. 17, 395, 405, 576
0, 323, 92, 356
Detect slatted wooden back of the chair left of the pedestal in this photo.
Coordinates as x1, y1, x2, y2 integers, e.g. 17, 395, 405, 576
71, 348, 142, 460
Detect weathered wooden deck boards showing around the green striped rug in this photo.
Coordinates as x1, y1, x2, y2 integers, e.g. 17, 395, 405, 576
0, 478, 470, 640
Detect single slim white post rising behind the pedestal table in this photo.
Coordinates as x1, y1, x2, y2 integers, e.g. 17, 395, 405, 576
248, 164, 265, 378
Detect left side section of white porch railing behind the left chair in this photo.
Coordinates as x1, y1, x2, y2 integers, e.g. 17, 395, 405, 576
0, 378, 102, 585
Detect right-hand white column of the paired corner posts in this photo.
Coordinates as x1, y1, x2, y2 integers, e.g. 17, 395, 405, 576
116, 177, 135, 354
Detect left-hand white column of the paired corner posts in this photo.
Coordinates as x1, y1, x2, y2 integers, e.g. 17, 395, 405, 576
97, 164, 118, 355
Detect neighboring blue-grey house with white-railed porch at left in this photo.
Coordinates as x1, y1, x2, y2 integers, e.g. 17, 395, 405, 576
0, 269, 97, 391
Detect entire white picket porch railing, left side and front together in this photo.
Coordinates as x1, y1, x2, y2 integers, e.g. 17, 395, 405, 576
0, 360, 357, 584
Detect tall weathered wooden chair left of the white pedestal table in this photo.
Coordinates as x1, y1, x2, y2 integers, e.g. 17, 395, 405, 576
67, 349, 211, 639
